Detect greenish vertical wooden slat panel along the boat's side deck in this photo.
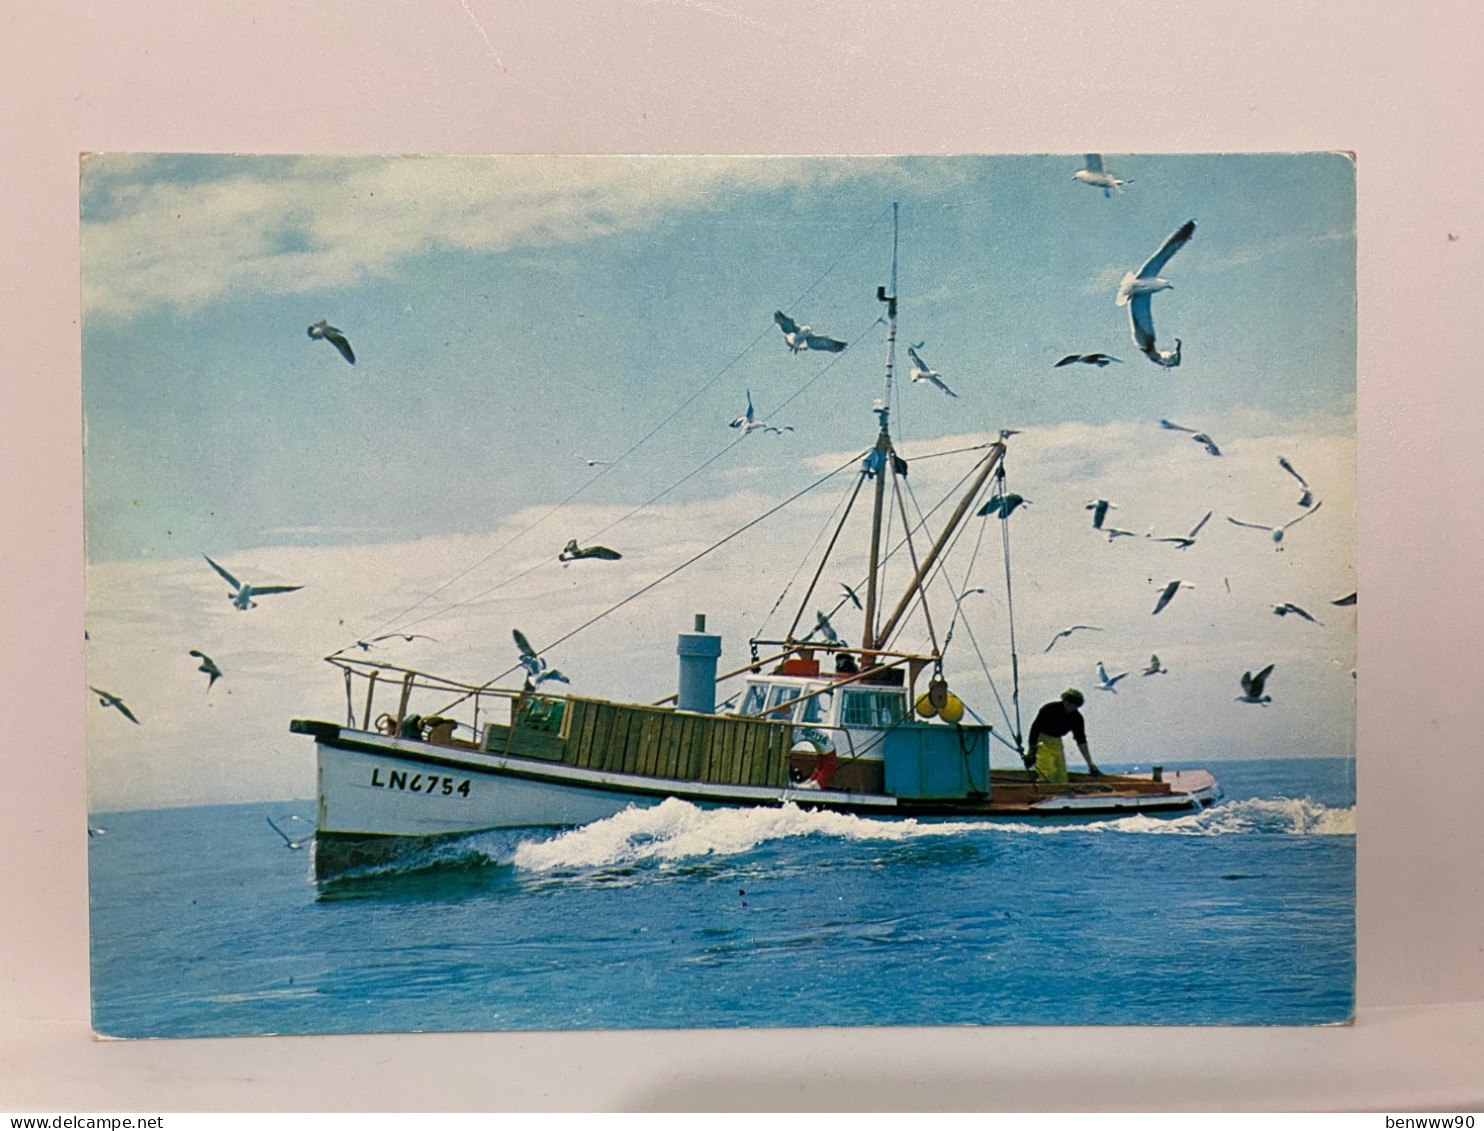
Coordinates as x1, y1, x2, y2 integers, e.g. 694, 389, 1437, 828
561, 698, 794, 787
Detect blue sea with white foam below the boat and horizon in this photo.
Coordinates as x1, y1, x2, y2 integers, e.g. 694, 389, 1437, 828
89, 758, 1355, 1037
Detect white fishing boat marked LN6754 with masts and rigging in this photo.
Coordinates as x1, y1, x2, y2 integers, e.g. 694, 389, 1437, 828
291, 209, 1221, 880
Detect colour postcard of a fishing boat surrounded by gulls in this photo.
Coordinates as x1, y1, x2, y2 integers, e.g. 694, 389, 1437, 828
82, 153, 1358, 1037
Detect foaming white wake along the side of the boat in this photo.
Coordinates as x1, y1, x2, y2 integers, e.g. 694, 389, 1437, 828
512, 797, 1355, 873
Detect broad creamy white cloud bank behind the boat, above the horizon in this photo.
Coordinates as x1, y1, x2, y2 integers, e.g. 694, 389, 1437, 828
88, 410, 1356, 810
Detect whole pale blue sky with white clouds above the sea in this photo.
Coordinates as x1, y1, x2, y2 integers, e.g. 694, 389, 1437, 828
82, 154, 1356, 812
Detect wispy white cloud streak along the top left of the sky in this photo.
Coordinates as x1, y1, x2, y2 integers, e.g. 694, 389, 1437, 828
82, 154, 892, 318
